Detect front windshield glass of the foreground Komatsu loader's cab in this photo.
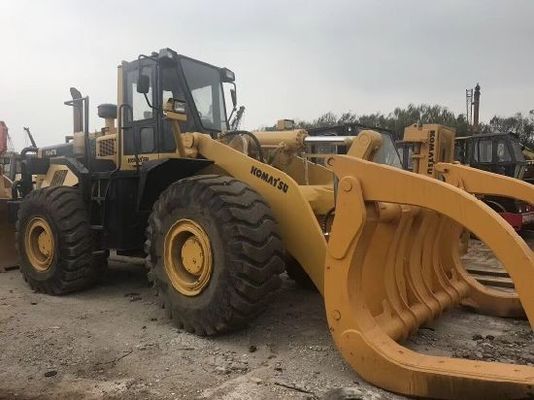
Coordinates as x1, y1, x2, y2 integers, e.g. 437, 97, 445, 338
181, 58, 228, 131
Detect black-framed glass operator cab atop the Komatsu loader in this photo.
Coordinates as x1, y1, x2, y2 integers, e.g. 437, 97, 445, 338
119, 49, 236, 159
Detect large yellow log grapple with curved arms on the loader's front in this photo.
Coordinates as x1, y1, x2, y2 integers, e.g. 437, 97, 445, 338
324, 156, 534, 399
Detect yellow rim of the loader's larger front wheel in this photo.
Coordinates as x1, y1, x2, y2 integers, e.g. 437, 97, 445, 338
163, 219, 213, 296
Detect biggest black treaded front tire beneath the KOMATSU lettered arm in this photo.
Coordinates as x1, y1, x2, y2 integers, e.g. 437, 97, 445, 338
145, 175, 284, 335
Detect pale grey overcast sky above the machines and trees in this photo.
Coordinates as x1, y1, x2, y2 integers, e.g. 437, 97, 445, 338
0, 0, 534, 150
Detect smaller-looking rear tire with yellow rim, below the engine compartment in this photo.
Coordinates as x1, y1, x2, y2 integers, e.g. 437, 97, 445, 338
16, 186, 101, 295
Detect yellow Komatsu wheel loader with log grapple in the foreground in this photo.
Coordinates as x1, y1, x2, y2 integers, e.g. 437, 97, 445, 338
3, 49, 534, 399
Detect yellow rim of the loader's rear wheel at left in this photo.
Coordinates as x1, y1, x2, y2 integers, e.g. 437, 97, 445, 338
24, 217, 55, 272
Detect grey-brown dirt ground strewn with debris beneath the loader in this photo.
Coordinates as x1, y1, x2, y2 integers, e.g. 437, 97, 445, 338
0, 238, 534, 400
